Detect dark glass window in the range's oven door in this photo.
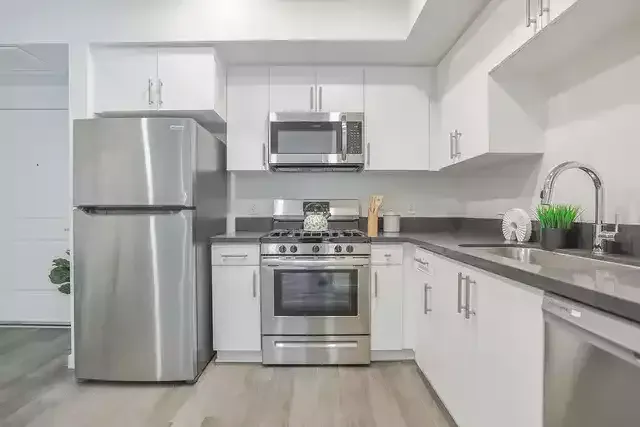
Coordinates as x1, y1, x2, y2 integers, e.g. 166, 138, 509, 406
274, 270, 358, 317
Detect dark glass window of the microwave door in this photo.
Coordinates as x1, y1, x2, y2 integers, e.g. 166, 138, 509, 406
271, 122, 342, 154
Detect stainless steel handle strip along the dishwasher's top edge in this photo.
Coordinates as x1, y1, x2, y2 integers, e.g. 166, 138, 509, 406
542, 295, 640, 366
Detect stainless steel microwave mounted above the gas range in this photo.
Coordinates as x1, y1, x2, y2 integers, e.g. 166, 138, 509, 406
268, 112, 364, 172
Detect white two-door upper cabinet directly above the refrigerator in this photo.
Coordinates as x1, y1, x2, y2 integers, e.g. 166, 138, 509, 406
93, 47, 227, 120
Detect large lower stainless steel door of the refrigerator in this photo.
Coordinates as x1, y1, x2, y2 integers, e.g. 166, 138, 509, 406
73, 209, 197, 381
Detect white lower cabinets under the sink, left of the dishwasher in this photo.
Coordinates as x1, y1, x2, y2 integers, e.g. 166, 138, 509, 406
416, 249, 544, 427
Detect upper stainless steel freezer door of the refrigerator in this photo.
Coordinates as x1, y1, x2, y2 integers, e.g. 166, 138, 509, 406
73, 118, 196, 206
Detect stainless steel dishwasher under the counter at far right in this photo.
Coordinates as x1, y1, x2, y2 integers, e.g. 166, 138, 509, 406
543, 295, 640, 427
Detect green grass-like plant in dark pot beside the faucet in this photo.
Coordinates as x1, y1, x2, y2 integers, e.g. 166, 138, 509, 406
536, 205, 581, 251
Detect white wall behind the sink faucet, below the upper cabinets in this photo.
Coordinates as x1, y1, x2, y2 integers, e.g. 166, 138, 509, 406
465, 28, 640, 224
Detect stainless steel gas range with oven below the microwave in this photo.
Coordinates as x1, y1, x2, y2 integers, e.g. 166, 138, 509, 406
261, 200, 371, 365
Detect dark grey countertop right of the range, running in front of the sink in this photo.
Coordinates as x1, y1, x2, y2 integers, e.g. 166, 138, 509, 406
371, 232, 640, 322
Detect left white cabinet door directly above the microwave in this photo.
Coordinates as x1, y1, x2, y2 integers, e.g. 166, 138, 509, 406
269, 67, 317, 112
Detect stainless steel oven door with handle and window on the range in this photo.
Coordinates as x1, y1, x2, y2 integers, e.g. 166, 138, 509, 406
261, 257, 370, 335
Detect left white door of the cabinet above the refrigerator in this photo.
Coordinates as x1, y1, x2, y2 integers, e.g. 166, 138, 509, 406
93, 48, 158, 113
